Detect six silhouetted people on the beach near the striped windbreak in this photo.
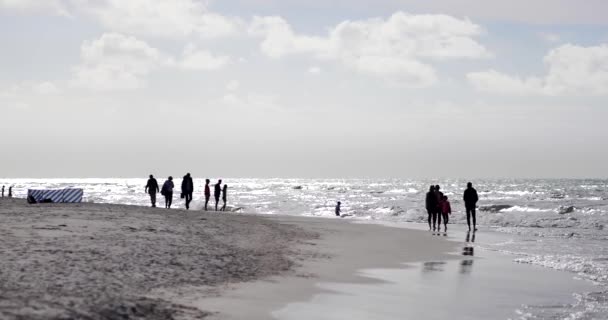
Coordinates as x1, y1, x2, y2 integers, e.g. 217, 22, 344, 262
145, 173, 228, 211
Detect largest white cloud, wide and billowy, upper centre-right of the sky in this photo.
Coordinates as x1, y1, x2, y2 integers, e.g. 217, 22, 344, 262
249, 12, 490, 87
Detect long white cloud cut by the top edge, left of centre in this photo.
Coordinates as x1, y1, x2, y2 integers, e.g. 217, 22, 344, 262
80, 0, 242, 38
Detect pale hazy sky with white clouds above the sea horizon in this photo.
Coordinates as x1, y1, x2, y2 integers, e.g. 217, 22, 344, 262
0, 0, 608, 179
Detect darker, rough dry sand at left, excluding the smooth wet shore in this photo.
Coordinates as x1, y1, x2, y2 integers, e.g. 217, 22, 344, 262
0, 198, 317, 319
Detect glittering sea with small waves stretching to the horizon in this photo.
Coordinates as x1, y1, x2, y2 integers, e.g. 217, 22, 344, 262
0, 178, 608, 319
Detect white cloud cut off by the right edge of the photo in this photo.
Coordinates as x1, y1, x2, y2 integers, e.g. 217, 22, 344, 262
467, 44, 608, 96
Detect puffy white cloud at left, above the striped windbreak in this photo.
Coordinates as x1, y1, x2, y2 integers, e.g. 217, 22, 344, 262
72, 33, 170, 90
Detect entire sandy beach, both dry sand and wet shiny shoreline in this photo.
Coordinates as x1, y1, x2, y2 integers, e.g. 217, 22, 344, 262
0, 199, 590, 319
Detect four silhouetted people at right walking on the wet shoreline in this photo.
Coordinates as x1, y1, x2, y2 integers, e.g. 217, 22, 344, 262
426, 182, 479, 232
